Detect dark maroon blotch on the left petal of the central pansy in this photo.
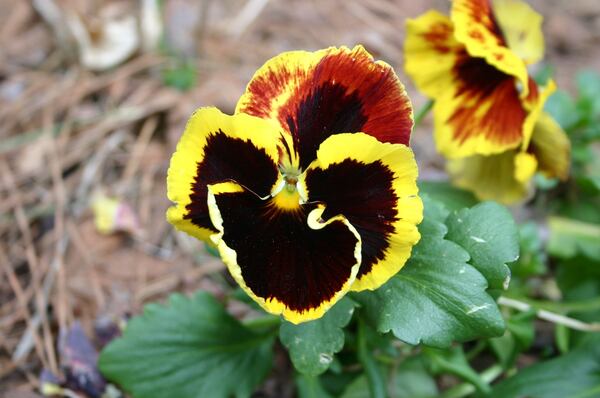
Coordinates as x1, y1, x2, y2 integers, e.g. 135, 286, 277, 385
184, 130, 279, 232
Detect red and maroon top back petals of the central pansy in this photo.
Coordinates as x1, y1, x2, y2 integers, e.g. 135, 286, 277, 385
238, 48, 413, 168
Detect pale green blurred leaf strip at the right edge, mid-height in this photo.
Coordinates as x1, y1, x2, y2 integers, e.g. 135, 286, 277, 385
548, 217, 600, 260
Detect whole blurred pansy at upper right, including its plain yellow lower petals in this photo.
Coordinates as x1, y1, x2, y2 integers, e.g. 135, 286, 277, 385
405, 0, 570, 203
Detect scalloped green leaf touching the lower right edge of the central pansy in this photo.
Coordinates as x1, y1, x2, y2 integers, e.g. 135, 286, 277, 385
355, 202, 504, 348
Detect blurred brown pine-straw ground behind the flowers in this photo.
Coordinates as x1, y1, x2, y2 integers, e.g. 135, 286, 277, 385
0, 0, 600, 397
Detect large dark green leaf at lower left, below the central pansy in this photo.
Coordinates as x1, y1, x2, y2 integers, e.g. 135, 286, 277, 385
99, 292, 273, 398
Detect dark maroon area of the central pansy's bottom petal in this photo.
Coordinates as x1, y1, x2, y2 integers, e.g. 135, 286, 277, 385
215, 192, 357, 312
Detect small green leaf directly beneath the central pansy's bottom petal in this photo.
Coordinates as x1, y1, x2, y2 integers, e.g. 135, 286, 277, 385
279, 298, 354, 376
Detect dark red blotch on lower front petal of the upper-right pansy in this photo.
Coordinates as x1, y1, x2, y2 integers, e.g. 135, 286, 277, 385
448, 53, 527, 144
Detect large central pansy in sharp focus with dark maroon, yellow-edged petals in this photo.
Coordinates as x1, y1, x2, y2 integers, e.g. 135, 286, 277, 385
167, 46, 423, 323
